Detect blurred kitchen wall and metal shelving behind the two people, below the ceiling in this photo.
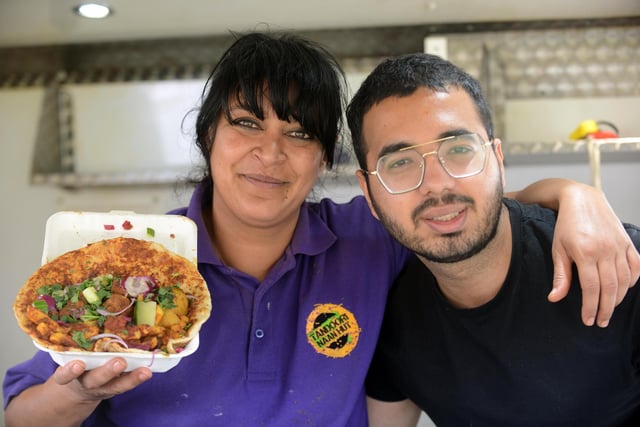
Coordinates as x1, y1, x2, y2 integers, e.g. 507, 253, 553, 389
0, 0, 640, 425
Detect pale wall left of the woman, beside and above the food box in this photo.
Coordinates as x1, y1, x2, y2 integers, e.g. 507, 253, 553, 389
0, 89, 189, 426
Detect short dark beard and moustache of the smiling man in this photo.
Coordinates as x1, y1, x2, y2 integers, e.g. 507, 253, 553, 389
369, 179, 504, 263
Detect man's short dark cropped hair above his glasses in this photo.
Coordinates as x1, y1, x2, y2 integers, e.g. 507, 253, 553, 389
347, 53, 493, 169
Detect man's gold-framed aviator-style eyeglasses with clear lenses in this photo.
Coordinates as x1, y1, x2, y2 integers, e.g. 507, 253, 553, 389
363, 133, 493, 194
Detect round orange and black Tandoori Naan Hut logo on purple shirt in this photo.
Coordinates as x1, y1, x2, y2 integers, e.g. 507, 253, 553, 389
306, 304, 360, 357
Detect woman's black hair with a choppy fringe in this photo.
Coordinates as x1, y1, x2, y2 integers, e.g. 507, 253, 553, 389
196, 33, 346, 192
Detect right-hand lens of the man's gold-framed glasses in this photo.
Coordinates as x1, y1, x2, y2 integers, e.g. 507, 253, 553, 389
438, 134, 486, 178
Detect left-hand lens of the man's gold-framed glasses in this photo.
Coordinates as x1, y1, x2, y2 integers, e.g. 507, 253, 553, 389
377, 150, 424, 193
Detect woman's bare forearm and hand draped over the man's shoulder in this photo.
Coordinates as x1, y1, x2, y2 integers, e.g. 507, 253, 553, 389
506, 178, 640, 327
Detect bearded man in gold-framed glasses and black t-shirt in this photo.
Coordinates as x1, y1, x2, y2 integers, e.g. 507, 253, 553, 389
347, 54, 640, 427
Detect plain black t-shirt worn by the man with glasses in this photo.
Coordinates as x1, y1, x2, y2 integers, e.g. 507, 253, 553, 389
367, 200, 640, 427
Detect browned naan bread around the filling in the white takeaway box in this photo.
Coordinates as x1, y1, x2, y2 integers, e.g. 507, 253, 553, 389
13, 237, 211, 353
